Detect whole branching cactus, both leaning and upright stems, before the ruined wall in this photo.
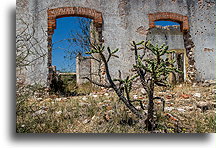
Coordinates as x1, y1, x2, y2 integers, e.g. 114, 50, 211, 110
85, 41, 180, 131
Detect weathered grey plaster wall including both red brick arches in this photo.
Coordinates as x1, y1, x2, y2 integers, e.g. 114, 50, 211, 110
16, 0, 216, 84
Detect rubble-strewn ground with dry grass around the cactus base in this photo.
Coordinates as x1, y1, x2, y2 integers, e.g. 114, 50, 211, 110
17, 82, 216, 133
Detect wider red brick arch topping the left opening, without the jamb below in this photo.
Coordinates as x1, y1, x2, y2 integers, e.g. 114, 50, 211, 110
47, 7, 103, 34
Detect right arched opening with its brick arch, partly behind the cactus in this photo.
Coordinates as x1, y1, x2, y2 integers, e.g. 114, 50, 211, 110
147, 12, 189, 83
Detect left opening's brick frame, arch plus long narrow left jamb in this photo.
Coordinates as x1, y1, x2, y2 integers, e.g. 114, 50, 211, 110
47, 7, 103, 85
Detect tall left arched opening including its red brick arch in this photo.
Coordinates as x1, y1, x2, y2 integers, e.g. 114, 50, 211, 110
47, 7, 103, 95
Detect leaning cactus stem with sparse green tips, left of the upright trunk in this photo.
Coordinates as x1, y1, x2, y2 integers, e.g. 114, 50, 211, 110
83, 44, 144, 119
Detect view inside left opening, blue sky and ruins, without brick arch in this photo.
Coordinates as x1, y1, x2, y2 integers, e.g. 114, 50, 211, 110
50, 17, 95, 96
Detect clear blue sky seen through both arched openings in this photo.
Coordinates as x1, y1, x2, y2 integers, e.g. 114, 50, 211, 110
52, 17, 179, 72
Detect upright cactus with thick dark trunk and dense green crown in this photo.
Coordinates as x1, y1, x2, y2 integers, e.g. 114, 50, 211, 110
131, 41, 180, 131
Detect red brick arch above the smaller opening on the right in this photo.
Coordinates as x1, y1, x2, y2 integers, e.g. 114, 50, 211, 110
148, 12, 189, 31
